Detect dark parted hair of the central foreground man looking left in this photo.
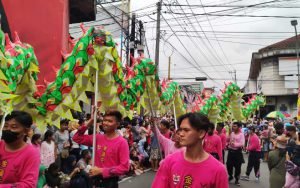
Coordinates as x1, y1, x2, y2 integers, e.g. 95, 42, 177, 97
178, 112, 210, 132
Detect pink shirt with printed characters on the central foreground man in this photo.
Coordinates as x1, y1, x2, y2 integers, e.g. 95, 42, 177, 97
152, 151, 229, 188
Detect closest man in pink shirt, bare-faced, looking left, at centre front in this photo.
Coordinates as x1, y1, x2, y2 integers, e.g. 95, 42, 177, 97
152, 113, 229, 188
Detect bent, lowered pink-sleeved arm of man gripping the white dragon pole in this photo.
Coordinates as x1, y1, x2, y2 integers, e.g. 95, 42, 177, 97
102, 141, 130, 178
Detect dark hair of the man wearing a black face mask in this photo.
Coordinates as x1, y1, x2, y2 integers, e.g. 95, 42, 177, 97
5, 111, 33, 128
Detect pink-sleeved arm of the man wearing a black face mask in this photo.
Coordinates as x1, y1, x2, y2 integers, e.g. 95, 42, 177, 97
0, 151, 40, 188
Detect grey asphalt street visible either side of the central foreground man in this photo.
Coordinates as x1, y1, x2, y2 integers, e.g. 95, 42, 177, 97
119, 155, 269, 188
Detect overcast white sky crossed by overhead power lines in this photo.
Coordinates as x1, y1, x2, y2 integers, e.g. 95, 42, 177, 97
131, 0, 300, 87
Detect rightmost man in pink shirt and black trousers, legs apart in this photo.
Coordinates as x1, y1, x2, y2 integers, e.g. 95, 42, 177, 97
241, 126, 261, 181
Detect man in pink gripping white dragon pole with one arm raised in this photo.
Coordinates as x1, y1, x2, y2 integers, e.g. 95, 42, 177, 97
73, 111, 130, 188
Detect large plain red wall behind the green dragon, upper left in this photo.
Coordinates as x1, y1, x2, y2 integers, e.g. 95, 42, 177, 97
2, 0, 69, 84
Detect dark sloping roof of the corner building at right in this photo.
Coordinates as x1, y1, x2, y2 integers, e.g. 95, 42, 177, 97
258, 35, 300, 53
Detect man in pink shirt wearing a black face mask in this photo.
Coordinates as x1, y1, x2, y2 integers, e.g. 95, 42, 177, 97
0, 111, 40, 188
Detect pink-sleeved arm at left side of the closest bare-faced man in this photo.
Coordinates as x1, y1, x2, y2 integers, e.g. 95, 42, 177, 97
152, 160, 171, 188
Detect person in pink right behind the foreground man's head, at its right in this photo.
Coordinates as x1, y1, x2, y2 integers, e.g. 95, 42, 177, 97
203, 123, 223, 163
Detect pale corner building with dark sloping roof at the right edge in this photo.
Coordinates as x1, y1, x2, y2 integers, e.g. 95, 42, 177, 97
244, 36, 299, 117
